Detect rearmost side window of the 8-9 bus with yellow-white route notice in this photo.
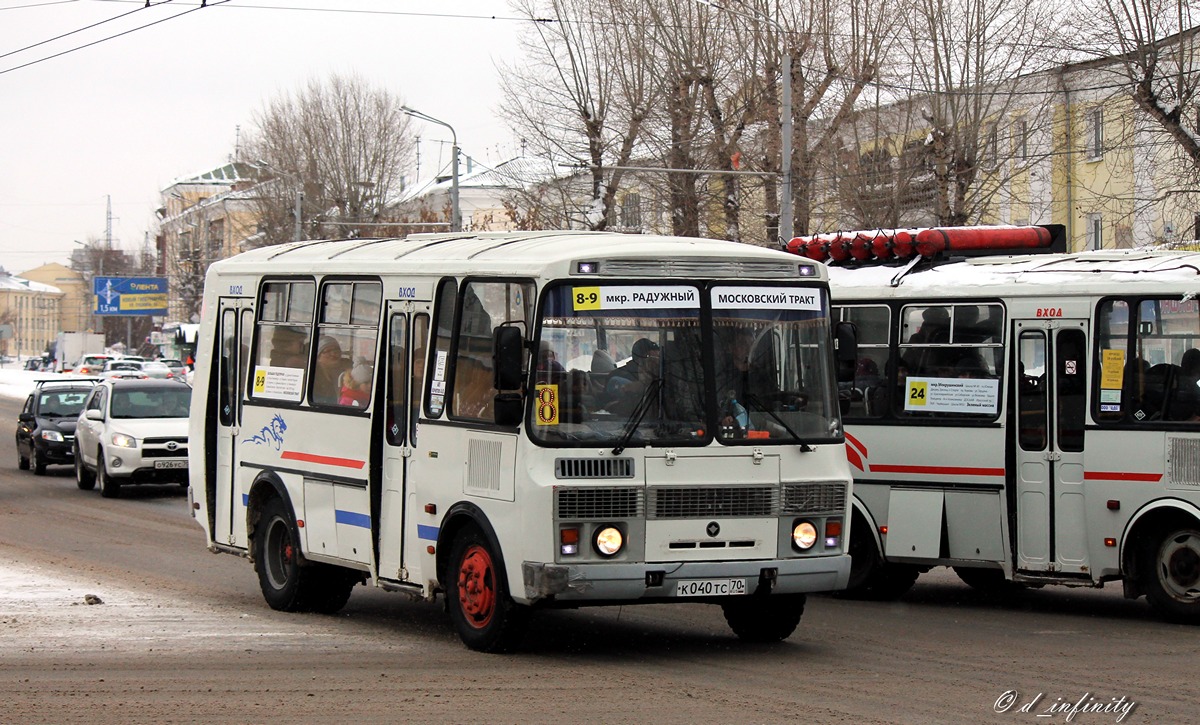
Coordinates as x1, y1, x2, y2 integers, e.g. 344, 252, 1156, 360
251, 281, 316, 402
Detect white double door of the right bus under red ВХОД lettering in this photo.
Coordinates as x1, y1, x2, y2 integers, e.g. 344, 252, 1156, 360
1015, 319, 1088, 574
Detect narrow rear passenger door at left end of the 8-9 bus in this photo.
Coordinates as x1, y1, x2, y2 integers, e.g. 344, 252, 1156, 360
214, 299, 254, 546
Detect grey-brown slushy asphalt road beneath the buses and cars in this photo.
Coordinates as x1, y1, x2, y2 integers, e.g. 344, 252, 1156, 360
0, 400, 1200, 724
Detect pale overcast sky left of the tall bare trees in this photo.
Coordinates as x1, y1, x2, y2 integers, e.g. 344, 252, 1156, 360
0, 0, 523, 274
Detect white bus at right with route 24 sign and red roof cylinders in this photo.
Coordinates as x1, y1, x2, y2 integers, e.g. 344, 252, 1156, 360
791, 227, 1200, 623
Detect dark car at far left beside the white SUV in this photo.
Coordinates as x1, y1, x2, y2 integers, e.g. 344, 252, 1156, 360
17, 381, 92, 475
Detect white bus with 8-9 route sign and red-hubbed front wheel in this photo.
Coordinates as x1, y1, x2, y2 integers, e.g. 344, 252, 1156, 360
190, 232, 853, 651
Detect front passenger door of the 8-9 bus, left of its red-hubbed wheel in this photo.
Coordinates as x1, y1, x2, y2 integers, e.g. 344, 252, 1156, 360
376, 302, 430, 581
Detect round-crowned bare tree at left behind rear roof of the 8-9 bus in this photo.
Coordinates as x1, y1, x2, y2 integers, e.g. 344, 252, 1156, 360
246, 76, 415, 244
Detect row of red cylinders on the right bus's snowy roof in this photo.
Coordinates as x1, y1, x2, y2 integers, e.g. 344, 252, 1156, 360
785, 224, 1066, 263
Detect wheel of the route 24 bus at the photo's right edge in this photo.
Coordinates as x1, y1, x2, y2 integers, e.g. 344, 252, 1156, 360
1139, 522, 1200, 624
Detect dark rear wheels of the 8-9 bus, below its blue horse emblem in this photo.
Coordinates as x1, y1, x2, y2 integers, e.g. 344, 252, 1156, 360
254, 497, 350, 615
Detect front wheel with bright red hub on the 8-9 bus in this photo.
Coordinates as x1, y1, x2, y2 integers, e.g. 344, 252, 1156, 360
445, 526, 529, 653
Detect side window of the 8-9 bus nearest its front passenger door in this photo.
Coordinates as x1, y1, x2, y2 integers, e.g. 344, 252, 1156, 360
310, 281, 383, 409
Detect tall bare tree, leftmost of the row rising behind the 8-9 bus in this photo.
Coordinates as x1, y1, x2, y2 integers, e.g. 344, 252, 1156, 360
502, 0, 658, 229
